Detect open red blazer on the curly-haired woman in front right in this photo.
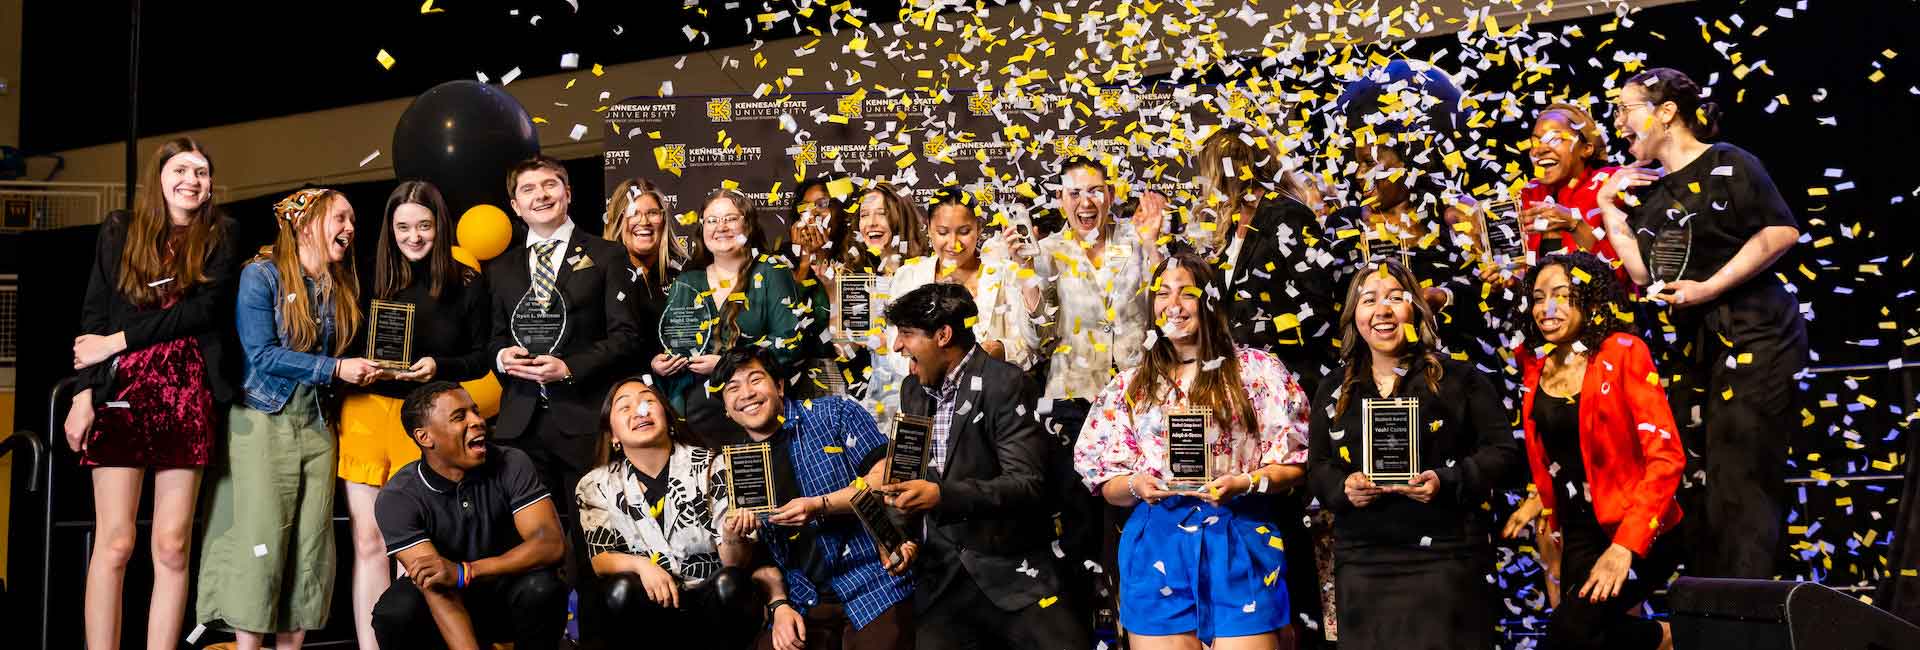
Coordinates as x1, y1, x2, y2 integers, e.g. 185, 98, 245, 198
1515, 334, 1686, 556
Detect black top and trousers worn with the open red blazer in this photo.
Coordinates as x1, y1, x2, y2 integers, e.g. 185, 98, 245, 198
1532, 391, 1678, 650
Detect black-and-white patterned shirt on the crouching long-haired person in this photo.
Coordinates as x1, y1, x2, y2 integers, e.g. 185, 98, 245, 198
574, 443, 728, 589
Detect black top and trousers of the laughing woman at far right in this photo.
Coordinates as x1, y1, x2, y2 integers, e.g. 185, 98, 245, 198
1630, 142, 1809, 579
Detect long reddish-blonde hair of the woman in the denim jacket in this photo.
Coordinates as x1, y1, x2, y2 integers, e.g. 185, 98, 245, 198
253, 190, 361, 355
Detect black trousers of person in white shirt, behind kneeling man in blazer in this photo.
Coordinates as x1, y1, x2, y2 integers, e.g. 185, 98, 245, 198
1041, 399, 1127, 640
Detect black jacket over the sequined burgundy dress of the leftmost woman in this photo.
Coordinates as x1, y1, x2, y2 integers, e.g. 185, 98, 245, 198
79, 211, 240, 406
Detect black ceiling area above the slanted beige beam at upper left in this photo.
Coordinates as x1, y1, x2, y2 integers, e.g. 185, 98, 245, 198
19, 0, 899, 153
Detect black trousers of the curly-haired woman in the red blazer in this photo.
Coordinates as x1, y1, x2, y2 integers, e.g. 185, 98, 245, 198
1542, 510, 1680, 650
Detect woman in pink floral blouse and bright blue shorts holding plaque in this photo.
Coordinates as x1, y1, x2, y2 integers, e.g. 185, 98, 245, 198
1073, 253, 1308, 650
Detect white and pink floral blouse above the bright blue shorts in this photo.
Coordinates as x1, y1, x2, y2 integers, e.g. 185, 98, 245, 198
1073, 347, 1308, 491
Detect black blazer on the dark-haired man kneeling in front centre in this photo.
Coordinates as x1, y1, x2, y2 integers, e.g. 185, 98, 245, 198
900, 347, 1060, 612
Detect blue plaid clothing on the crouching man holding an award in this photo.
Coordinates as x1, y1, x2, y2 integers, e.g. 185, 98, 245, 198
762, 397, 914, 629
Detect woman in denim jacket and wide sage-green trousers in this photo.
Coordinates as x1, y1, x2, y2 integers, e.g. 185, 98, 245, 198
198, 190, 380, 650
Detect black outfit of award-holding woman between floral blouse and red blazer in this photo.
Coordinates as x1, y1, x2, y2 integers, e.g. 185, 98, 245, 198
1308, 360, 1524, 650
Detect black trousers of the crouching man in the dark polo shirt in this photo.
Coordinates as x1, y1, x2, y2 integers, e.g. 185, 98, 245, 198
372, 569, 566, 650
